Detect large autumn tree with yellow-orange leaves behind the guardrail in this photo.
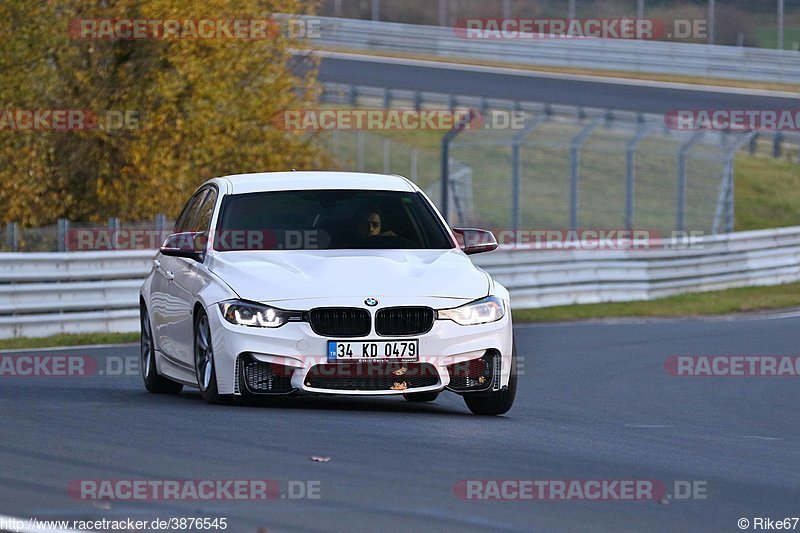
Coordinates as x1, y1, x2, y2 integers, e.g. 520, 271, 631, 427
0, 0, 325, 225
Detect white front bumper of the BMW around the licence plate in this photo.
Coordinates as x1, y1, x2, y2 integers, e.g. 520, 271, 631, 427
206, 299, 513, 396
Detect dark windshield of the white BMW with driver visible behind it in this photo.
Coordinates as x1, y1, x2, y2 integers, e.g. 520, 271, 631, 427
212, 190, 454, 252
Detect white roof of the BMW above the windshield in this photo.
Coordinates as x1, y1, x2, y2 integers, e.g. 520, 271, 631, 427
212, 171, 419, 194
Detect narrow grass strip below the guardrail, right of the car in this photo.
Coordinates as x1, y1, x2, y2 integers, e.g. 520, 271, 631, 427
513, 283, 800, 323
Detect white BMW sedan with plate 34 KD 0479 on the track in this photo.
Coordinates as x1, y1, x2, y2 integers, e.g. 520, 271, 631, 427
140, 172, 517, 415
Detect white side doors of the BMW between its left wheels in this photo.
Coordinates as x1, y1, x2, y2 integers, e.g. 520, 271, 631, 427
152, 187, 209, 368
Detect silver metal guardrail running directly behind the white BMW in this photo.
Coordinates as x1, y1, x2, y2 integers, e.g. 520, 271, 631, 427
0, 227, 800, 338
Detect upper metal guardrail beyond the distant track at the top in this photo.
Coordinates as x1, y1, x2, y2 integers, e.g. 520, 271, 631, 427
311, 17, 800, 83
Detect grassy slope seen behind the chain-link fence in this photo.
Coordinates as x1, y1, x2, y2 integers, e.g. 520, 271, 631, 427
321, 118, 800, 234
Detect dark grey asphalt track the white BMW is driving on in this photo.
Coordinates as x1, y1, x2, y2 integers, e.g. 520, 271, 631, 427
0, 316, 800, 532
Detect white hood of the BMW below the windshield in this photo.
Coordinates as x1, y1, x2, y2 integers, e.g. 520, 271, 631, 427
208, 249, 489, 302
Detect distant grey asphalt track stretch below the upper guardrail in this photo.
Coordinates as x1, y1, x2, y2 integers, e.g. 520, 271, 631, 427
308, 54, 800, 113
